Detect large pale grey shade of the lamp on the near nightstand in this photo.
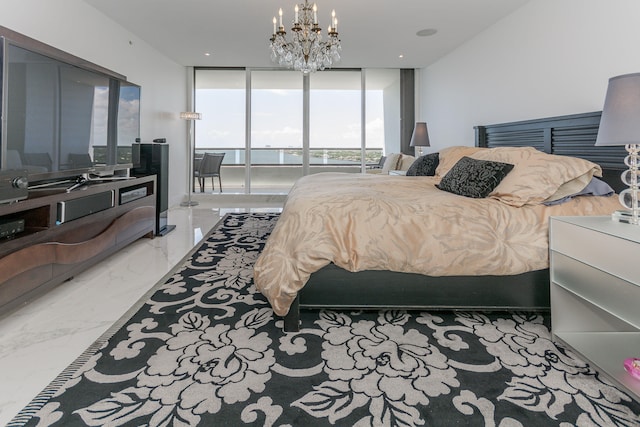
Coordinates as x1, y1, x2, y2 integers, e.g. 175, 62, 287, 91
596, 73, 640, 145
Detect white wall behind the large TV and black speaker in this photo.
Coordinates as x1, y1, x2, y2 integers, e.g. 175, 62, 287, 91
0, 0, 187, 205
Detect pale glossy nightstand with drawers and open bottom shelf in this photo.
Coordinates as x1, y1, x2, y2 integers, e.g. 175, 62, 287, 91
549, 216, 640, 401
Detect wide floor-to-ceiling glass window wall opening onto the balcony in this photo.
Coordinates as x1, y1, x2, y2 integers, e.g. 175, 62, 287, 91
194, 68, 400, 193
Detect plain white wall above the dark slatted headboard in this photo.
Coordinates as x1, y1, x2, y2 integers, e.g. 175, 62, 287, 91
418, 0, 640, 150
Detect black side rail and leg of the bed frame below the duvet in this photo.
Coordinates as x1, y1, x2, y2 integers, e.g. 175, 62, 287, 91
284, 264, 550, 332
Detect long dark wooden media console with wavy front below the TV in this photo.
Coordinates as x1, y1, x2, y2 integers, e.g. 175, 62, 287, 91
0, 175, 156, 311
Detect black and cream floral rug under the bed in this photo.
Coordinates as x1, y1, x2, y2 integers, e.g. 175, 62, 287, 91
9, 213, 640, 427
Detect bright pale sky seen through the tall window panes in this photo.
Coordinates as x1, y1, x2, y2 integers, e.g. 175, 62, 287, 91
195, 89, 384, 149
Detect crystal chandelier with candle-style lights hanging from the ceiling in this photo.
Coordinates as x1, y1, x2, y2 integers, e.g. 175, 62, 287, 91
271, 0, 342, 74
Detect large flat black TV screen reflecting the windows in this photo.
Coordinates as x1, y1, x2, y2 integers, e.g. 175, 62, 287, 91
0, 29, 140, 182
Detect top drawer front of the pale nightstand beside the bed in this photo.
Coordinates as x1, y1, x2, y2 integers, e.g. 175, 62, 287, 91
549, 219, 640, 283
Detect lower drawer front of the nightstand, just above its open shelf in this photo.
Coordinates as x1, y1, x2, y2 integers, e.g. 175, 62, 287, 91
551, 251, 640, 329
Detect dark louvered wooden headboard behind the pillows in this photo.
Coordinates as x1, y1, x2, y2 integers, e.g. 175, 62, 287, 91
475, 111, 627, 192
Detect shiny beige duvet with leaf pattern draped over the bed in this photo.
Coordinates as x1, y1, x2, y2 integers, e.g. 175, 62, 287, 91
254, 173, 619, 316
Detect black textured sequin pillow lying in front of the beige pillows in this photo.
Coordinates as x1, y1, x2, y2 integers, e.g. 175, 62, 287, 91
436, 156, 513, 199
